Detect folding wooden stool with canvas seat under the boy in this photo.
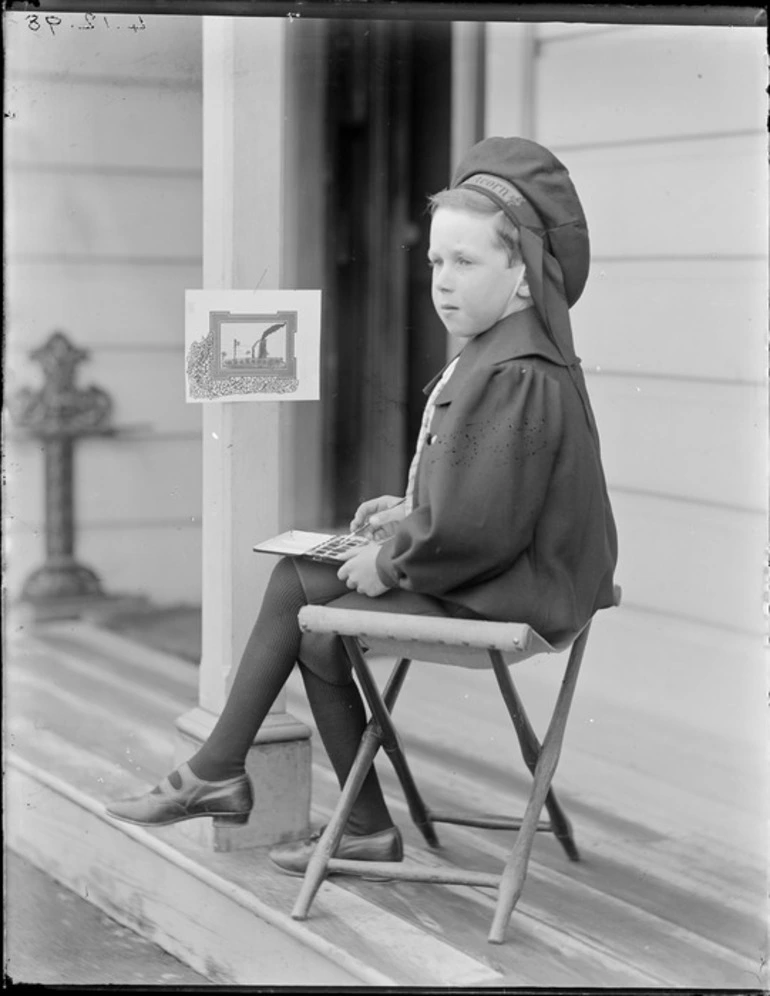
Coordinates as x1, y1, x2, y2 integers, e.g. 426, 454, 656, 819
292, 587, 620, 944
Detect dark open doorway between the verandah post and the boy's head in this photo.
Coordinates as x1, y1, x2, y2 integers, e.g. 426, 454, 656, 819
324, 21, 451, 524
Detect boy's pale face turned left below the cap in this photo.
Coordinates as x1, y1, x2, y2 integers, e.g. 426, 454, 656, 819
428, 207, 529, 339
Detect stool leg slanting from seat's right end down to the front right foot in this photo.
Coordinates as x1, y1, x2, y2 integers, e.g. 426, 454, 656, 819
488, 626, 589, 944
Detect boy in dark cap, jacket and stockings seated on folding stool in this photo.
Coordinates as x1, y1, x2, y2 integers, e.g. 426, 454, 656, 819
108, 138, 617, 874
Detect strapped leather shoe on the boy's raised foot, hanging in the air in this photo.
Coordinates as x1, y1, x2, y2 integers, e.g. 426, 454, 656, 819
102, 764, 254, 827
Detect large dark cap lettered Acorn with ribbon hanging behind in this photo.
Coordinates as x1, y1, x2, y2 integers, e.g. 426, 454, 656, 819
452, 138, 591, 363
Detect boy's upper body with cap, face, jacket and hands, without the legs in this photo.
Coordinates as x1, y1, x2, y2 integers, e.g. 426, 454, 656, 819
340, 138, 617, 642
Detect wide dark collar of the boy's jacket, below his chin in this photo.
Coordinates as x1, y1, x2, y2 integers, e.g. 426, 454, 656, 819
423, 307, 567, 402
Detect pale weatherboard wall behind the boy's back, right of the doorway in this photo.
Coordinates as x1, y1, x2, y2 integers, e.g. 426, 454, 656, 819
486, 24, 767, 635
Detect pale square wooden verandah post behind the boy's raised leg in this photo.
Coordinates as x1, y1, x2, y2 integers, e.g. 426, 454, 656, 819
177, 17, 310, 850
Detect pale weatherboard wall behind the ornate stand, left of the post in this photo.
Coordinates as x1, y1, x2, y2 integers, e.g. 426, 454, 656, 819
4, 13, 202, 603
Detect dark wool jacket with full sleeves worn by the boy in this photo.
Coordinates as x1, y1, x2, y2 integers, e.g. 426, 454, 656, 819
377, 308, 617, 643
